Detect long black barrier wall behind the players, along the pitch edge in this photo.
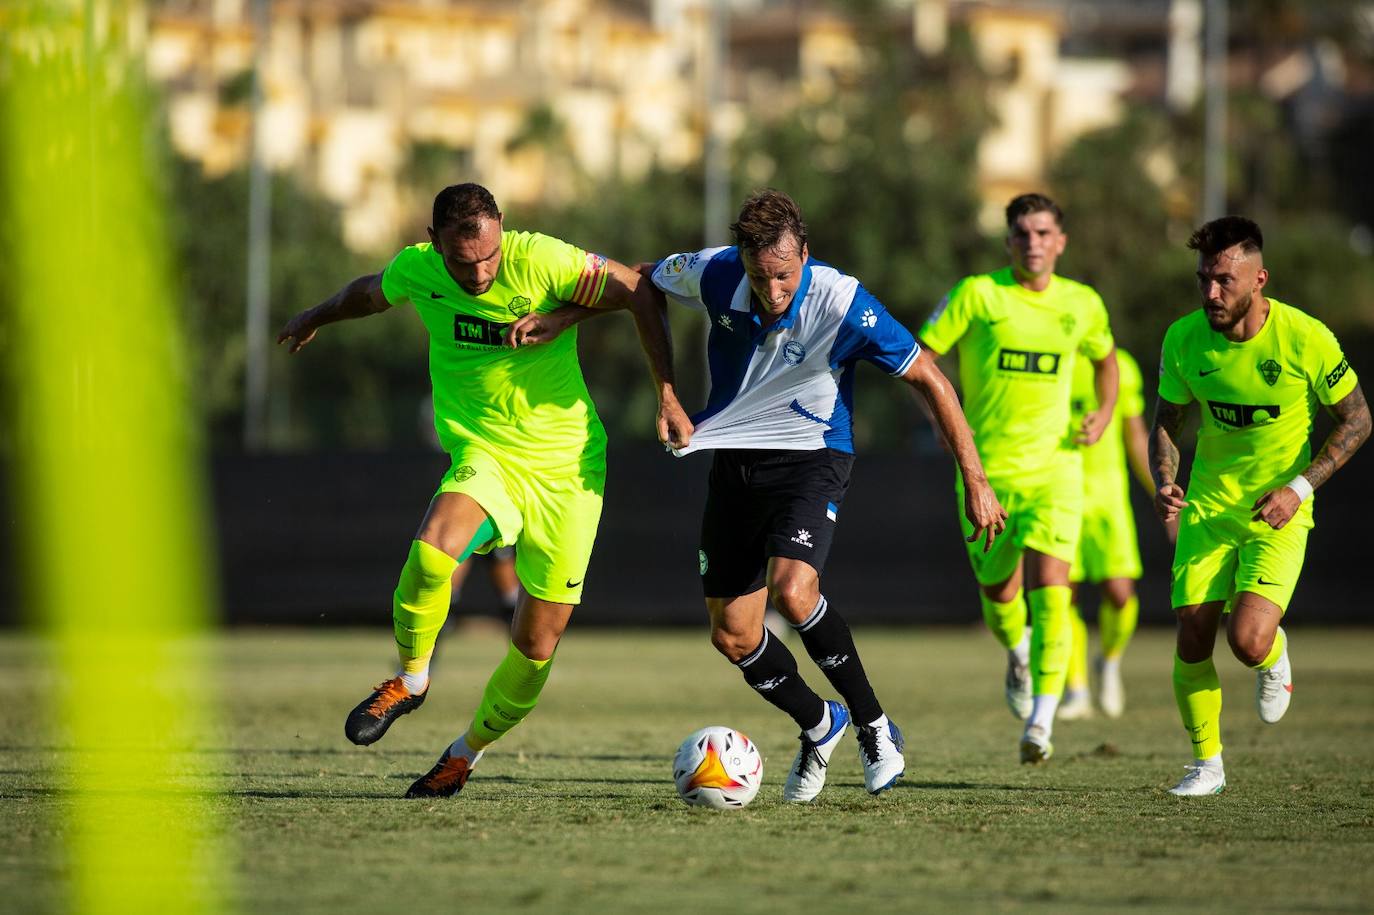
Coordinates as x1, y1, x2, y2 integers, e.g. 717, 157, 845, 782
0, 445, 1357, 625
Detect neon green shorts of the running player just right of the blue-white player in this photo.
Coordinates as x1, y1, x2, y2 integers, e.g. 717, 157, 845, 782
955, 453, 1083, 584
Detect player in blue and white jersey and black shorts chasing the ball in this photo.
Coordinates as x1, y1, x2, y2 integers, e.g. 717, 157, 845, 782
513, 190, 1006, 802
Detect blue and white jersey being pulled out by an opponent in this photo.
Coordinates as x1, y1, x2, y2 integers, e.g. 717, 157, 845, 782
653, 247, 921, 455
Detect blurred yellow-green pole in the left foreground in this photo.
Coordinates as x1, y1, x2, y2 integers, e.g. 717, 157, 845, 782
0, 0, 232, 912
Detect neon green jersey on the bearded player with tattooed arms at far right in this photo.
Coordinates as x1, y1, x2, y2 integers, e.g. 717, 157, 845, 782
1160, 298, 1356, 514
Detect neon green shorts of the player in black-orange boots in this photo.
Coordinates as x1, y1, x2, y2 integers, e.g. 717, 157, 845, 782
436, 444, 606, 603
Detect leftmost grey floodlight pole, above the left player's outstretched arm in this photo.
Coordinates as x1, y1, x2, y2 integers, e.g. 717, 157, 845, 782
243, 0, 272, 452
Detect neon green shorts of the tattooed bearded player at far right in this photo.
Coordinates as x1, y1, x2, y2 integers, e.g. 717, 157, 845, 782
1171, 504, 1312, 610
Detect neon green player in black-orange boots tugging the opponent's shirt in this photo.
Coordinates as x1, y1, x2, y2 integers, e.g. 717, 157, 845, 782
278, 184, 691, 797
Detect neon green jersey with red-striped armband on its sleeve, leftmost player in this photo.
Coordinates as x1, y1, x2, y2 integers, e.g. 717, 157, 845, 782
382, 232, 606, 475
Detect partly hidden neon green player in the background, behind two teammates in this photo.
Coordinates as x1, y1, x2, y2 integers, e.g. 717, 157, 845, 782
1058, 346, 1154, 721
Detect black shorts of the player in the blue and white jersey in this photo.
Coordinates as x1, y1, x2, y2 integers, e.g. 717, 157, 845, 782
698, 448, 855, 598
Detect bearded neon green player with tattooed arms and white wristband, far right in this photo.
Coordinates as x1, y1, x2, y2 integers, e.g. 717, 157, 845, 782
1150, 216, 1370, 797
